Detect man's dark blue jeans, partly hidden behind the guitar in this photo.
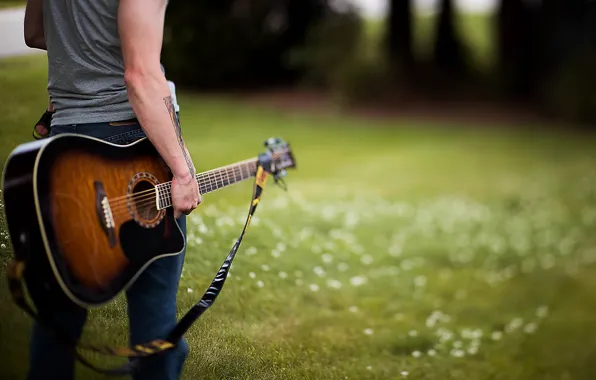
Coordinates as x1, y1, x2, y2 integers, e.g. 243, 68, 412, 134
27, 121, 188, 380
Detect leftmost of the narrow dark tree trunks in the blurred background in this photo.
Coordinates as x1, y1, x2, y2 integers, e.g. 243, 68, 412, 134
384, 0, 414, 72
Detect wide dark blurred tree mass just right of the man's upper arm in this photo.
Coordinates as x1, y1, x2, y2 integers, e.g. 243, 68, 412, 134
162, 0, 332, 89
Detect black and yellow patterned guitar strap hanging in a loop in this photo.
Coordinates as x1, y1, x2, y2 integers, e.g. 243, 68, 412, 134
7, 159, 270, 375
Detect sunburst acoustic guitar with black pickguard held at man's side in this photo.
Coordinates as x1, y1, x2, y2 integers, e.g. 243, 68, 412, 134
3, 134, 295, 308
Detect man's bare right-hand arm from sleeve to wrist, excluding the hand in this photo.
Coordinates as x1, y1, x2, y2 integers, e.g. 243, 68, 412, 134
118, 0, 195, 183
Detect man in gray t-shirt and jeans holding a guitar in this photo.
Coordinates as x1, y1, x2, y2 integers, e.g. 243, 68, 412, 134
24, 0, 201, 380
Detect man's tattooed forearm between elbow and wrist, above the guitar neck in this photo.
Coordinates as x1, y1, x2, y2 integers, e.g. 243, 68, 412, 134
125, 71, 196, 179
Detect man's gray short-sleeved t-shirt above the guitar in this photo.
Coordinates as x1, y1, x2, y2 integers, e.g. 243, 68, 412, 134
43, 0, 174, 125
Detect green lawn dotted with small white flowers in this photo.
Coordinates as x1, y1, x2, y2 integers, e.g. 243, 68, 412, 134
0, 56, 596, 380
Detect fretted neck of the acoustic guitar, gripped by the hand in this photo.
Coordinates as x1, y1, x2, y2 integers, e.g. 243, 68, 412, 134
156, 158, 257, 209
